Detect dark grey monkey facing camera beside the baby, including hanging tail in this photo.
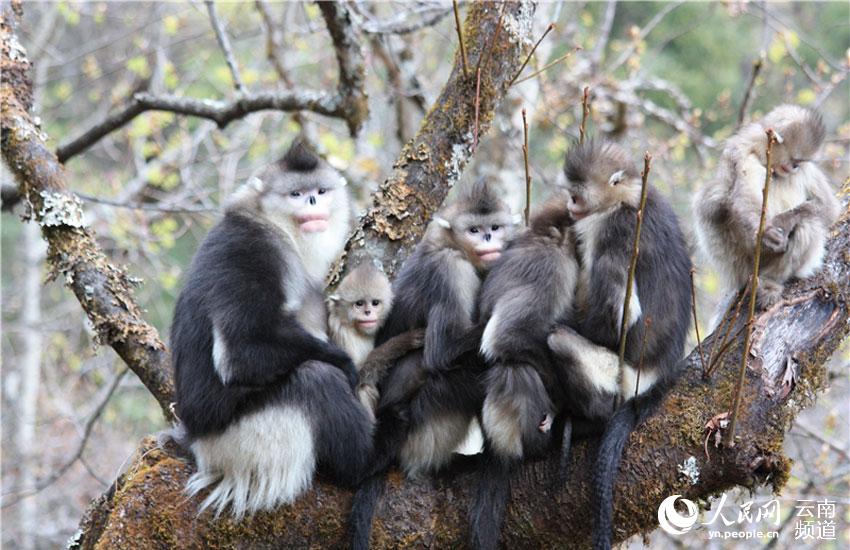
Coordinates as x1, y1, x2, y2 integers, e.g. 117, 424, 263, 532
350, 181, 516, 549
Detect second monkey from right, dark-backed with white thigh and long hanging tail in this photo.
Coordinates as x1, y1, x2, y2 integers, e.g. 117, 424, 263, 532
547, 141, 691, 549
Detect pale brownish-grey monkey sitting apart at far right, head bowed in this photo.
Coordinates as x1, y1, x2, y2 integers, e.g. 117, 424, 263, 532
693, 105, 840, 316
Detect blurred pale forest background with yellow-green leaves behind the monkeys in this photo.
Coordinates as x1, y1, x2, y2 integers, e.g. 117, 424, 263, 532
2, 1, 850, 548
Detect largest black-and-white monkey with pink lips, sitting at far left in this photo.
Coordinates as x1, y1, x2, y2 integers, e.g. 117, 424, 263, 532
171, 142, 373, 518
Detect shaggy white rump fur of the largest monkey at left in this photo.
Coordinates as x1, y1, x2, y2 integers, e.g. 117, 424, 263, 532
186, 405, 316, 519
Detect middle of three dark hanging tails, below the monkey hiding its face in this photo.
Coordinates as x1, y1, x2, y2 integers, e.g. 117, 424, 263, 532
469, 449, 517, 550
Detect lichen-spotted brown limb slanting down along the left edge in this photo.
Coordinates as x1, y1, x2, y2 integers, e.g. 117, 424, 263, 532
0, 4, 174, 418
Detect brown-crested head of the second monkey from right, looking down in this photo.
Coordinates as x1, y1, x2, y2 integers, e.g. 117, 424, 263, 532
564, 142, 640, 221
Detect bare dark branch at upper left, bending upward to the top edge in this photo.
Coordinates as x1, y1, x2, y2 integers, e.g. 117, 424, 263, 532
56, 2, 369, 163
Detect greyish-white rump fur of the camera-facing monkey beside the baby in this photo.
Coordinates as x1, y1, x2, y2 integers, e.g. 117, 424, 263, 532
400, 415, 469, 478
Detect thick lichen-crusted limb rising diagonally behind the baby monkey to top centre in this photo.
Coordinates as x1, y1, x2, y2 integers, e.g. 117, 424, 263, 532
331, 2, 534, 284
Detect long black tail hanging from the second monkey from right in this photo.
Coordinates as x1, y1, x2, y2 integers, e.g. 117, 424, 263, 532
593, 390, 664, 550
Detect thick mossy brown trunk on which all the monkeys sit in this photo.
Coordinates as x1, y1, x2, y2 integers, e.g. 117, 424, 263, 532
71, 193, 850, 548
